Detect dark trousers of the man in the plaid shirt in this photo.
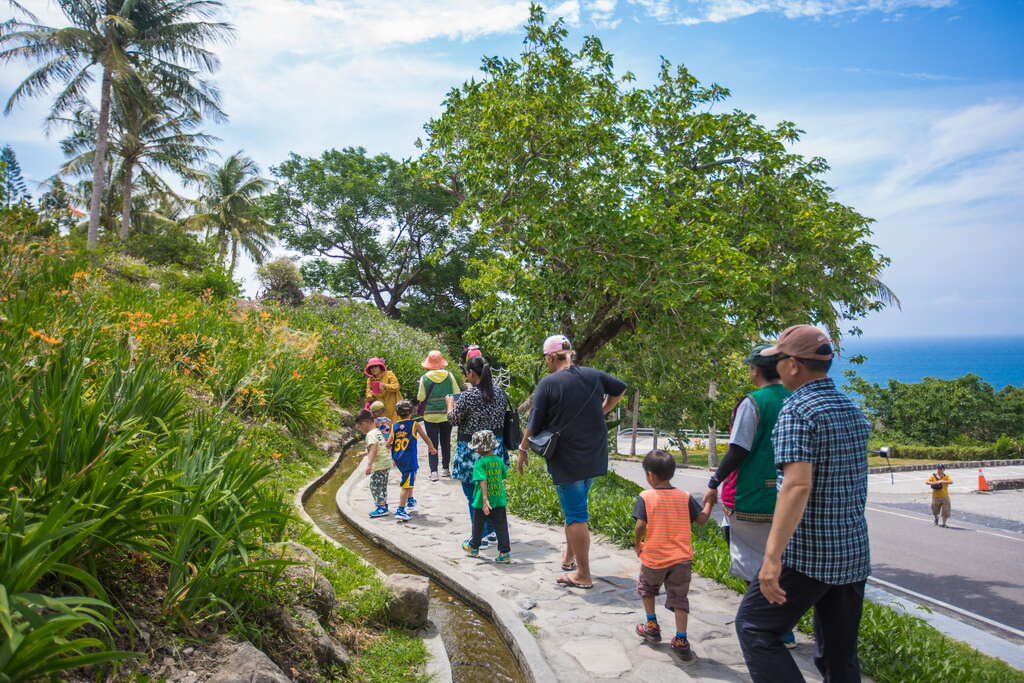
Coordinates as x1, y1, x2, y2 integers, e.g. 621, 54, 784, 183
736, 565, 864, 683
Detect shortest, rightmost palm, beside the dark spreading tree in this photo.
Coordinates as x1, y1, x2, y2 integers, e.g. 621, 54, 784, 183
186, 150, 274, 274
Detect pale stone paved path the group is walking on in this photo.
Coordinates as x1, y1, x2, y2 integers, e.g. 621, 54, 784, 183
348, 443, 820, 683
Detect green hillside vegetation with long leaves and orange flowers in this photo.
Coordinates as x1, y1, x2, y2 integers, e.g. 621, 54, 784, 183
0, 221, 436, 680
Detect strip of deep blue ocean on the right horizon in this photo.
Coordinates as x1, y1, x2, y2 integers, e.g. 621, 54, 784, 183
829, 337, 1024, 390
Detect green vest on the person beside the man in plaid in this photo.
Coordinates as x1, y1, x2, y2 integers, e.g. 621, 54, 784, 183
736, 384, 790, 521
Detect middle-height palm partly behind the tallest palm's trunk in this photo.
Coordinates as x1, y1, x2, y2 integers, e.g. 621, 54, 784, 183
51, 75, 218, 241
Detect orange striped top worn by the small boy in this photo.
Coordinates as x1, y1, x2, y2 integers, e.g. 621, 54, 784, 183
633, 488, 696, 569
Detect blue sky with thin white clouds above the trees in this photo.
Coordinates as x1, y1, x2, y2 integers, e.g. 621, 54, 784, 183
0, 0, 1024, 337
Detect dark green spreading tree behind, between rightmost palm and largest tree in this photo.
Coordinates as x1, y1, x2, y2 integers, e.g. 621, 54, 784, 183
268, 147, 469, 317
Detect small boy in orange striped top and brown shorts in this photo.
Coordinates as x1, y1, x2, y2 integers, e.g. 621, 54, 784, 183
633, 451, 712, 661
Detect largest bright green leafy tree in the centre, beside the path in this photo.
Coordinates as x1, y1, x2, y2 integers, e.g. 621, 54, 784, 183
423, 5, 887, 413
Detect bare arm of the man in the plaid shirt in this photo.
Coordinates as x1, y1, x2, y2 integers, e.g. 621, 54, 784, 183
758, 462, 814, 604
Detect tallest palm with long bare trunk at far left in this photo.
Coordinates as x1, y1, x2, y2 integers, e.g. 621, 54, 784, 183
0, 0, 233, 248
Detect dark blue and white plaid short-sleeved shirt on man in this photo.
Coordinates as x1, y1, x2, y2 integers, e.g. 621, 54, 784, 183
772, 378, 871, 586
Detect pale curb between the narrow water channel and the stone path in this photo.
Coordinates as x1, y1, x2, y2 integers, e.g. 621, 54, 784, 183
335, 468, 558, 683
